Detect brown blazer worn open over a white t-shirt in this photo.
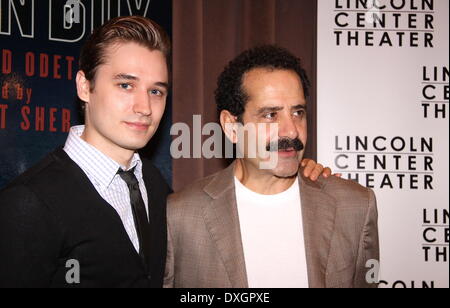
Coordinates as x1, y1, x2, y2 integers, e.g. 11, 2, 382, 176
164, 164, 379, 288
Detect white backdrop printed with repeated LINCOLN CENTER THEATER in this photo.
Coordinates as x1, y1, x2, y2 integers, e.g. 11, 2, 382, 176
317, 0, 449, 288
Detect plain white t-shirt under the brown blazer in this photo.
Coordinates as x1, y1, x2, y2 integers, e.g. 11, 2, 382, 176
235, 178, 308, 288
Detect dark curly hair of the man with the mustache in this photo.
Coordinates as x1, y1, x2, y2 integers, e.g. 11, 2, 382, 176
215, 45, 310, 122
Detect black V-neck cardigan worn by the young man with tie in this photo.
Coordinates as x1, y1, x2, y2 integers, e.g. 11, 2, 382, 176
0, 149, 171, 288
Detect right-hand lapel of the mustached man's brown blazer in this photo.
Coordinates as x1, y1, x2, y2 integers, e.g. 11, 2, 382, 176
299, 175, 336, 288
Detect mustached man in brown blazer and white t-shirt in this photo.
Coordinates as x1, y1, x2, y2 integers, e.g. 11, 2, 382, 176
165, 46, 379, 288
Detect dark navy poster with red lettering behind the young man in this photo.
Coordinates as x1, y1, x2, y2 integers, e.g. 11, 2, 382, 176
0, 0, 172, 189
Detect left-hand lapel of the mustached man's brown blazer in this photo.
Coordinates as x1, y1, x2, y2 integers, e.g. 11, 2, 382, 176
204, 163, 248, 288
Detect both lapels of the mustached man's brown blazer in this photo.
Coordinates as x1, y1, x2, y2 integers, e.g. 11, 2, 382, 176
204, 162, 336, 288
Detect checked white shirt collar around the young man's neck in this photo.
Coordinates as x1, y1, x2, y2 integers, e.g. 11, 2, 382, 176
64, 125, 142, 189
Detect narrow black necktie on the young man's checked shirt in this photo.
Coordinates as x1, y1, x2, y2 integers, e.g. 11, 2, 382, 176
117, 168, 150, 269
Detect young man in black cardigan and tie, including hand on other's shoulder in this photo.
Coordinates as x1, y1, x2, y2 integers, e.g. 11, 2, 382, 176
0, 16, 329, 287
